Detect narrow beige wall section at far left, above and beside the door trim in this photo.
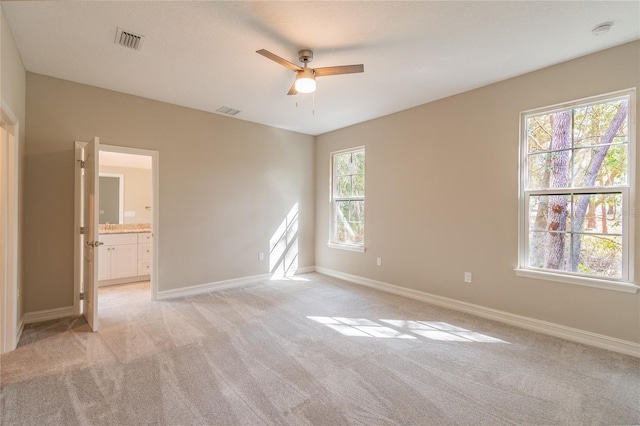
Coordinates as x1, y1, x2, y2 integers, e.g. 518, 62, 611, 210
0, 8, 26, 319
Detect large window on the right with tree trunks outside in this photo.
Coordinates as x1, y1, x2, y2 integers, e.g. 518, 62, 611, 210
520, 91, 635, 290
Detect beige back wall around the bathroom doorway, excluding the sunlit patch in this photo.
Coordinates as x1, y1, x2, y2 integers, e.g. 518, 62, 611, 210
24, 73, 314, 312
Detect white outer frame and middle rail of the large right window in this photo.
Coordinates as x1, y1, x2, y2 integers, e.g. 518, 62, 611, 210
515, 88, 640, 293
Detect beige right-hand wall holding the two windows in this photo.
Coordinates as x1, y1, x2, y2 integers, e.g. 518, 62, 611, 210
316, 42, 640, 342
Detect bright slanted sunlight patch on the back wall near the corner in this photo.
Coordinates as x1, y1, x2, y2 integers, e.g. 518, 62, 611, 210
269, 203, 298, 280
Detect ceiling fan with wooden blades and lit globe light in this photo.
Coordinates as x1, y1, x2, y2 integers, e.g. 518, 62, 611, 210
256, 49, 364, 95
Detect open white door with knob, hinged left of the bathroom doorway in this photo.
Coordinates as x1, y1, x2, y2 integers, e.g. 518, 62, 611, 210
76, 137, 102, 331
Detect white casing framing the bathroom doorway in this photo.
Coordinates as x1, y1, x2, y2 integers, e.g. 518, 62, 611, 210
73, 142, 160, 315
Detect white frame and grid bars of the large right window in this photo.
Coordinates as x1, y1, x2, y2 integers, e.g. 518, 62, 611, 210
515, 88, 640, 293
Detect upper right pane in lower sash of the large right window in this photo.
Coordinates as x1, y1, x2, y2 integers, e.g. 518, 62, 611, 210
572, 193, 622, 234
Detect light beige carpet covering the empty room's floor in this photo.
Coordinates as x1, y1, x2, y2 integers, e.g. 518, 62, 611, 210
0, 273, 640, 425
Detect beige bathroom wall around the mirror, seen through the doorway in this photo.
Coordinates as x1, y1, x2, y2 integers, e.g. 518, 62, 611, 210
100, 166, 151, 224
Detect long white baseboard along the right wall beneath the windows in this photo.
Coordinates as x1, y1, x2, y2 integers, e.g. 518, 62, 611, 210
314, 266, 640, 357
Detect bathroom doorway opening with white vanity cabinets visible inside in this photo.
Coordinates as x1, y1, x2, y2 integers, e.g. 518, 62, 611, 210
98, 145, 159, 317
